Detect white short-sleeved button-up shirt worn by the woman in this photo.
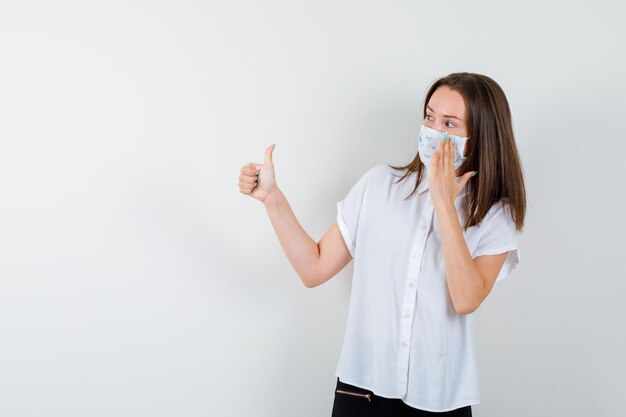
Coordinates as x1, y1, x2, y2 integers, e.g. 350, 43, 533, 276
335, 165, 519, 412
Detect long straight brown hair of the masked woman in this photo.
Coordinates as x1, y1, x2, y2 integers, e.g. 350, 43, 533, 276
388, 72, 526, 231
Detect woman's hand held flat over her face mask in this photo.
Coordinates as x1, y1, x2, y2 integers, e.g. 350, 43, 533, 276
428, 134, 476, 208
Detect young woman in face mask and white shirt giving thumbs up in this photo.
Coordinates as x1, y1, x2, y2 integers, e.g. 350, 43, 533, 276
239, 73, 526, 417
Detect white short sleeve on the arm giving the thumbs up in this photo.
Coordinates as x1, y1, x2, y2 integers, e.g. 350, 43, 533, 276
337, 166, 372, 258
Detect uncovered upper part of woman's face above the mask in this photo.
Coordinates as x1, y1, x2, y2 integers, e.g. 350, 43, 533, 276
423, 85, 467, 137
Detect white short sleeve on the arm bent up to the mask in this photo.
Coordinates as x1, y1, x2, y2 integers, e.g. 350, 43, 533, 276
472, 202, 520, 282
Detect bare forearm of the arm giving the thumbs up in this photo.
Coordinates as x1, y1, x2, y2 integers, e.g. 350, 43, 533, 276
263, 187, 320, 287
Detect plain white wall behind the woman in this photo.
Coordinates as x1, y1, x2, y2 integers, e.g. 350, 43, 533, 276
0, 0, 626, 417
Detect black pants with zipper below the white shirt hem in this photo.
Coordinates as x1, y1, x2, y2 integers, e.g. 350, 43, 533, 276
331, 378, 472, 417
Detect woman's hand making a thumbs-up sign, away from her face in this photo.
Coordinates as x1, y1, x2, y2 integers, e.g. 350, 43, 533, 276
239, 144, 278, 202
